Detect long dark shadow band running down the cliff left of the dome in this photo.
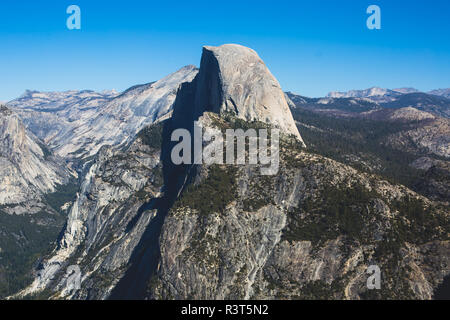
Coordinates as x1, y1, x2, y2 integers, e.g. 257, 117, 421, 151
108, 80, 200, 300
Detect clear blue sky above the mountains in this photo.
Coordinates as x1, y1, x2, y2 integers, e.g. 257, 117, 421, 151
0, 0, 450, 101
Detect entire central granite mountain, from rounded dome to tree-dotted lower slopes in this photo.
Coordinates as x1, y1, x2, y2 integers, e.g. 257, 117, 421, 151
5, 44, 450, 299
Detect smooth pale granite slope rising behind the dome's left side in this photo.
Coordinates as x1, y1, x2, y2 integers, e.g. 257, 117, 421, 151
56, 66, 198, 158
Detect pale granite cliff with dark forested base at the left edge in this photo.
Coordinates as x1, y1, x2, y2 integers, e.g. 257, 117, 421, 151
0, 106, 76, 299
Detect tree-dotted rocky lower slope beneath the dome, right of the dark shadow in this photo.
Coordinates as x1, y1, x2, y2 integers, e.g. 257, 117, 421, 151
153, 115, 450, 299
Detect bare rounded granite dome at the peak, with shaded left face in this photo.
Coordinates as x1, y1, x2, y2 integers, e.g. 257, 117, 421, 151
195, 44, 303, 142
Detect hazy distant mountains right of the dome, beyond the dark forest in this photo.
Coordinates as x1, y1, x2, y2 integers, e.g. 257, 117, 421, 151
286, 92, 450, 158
